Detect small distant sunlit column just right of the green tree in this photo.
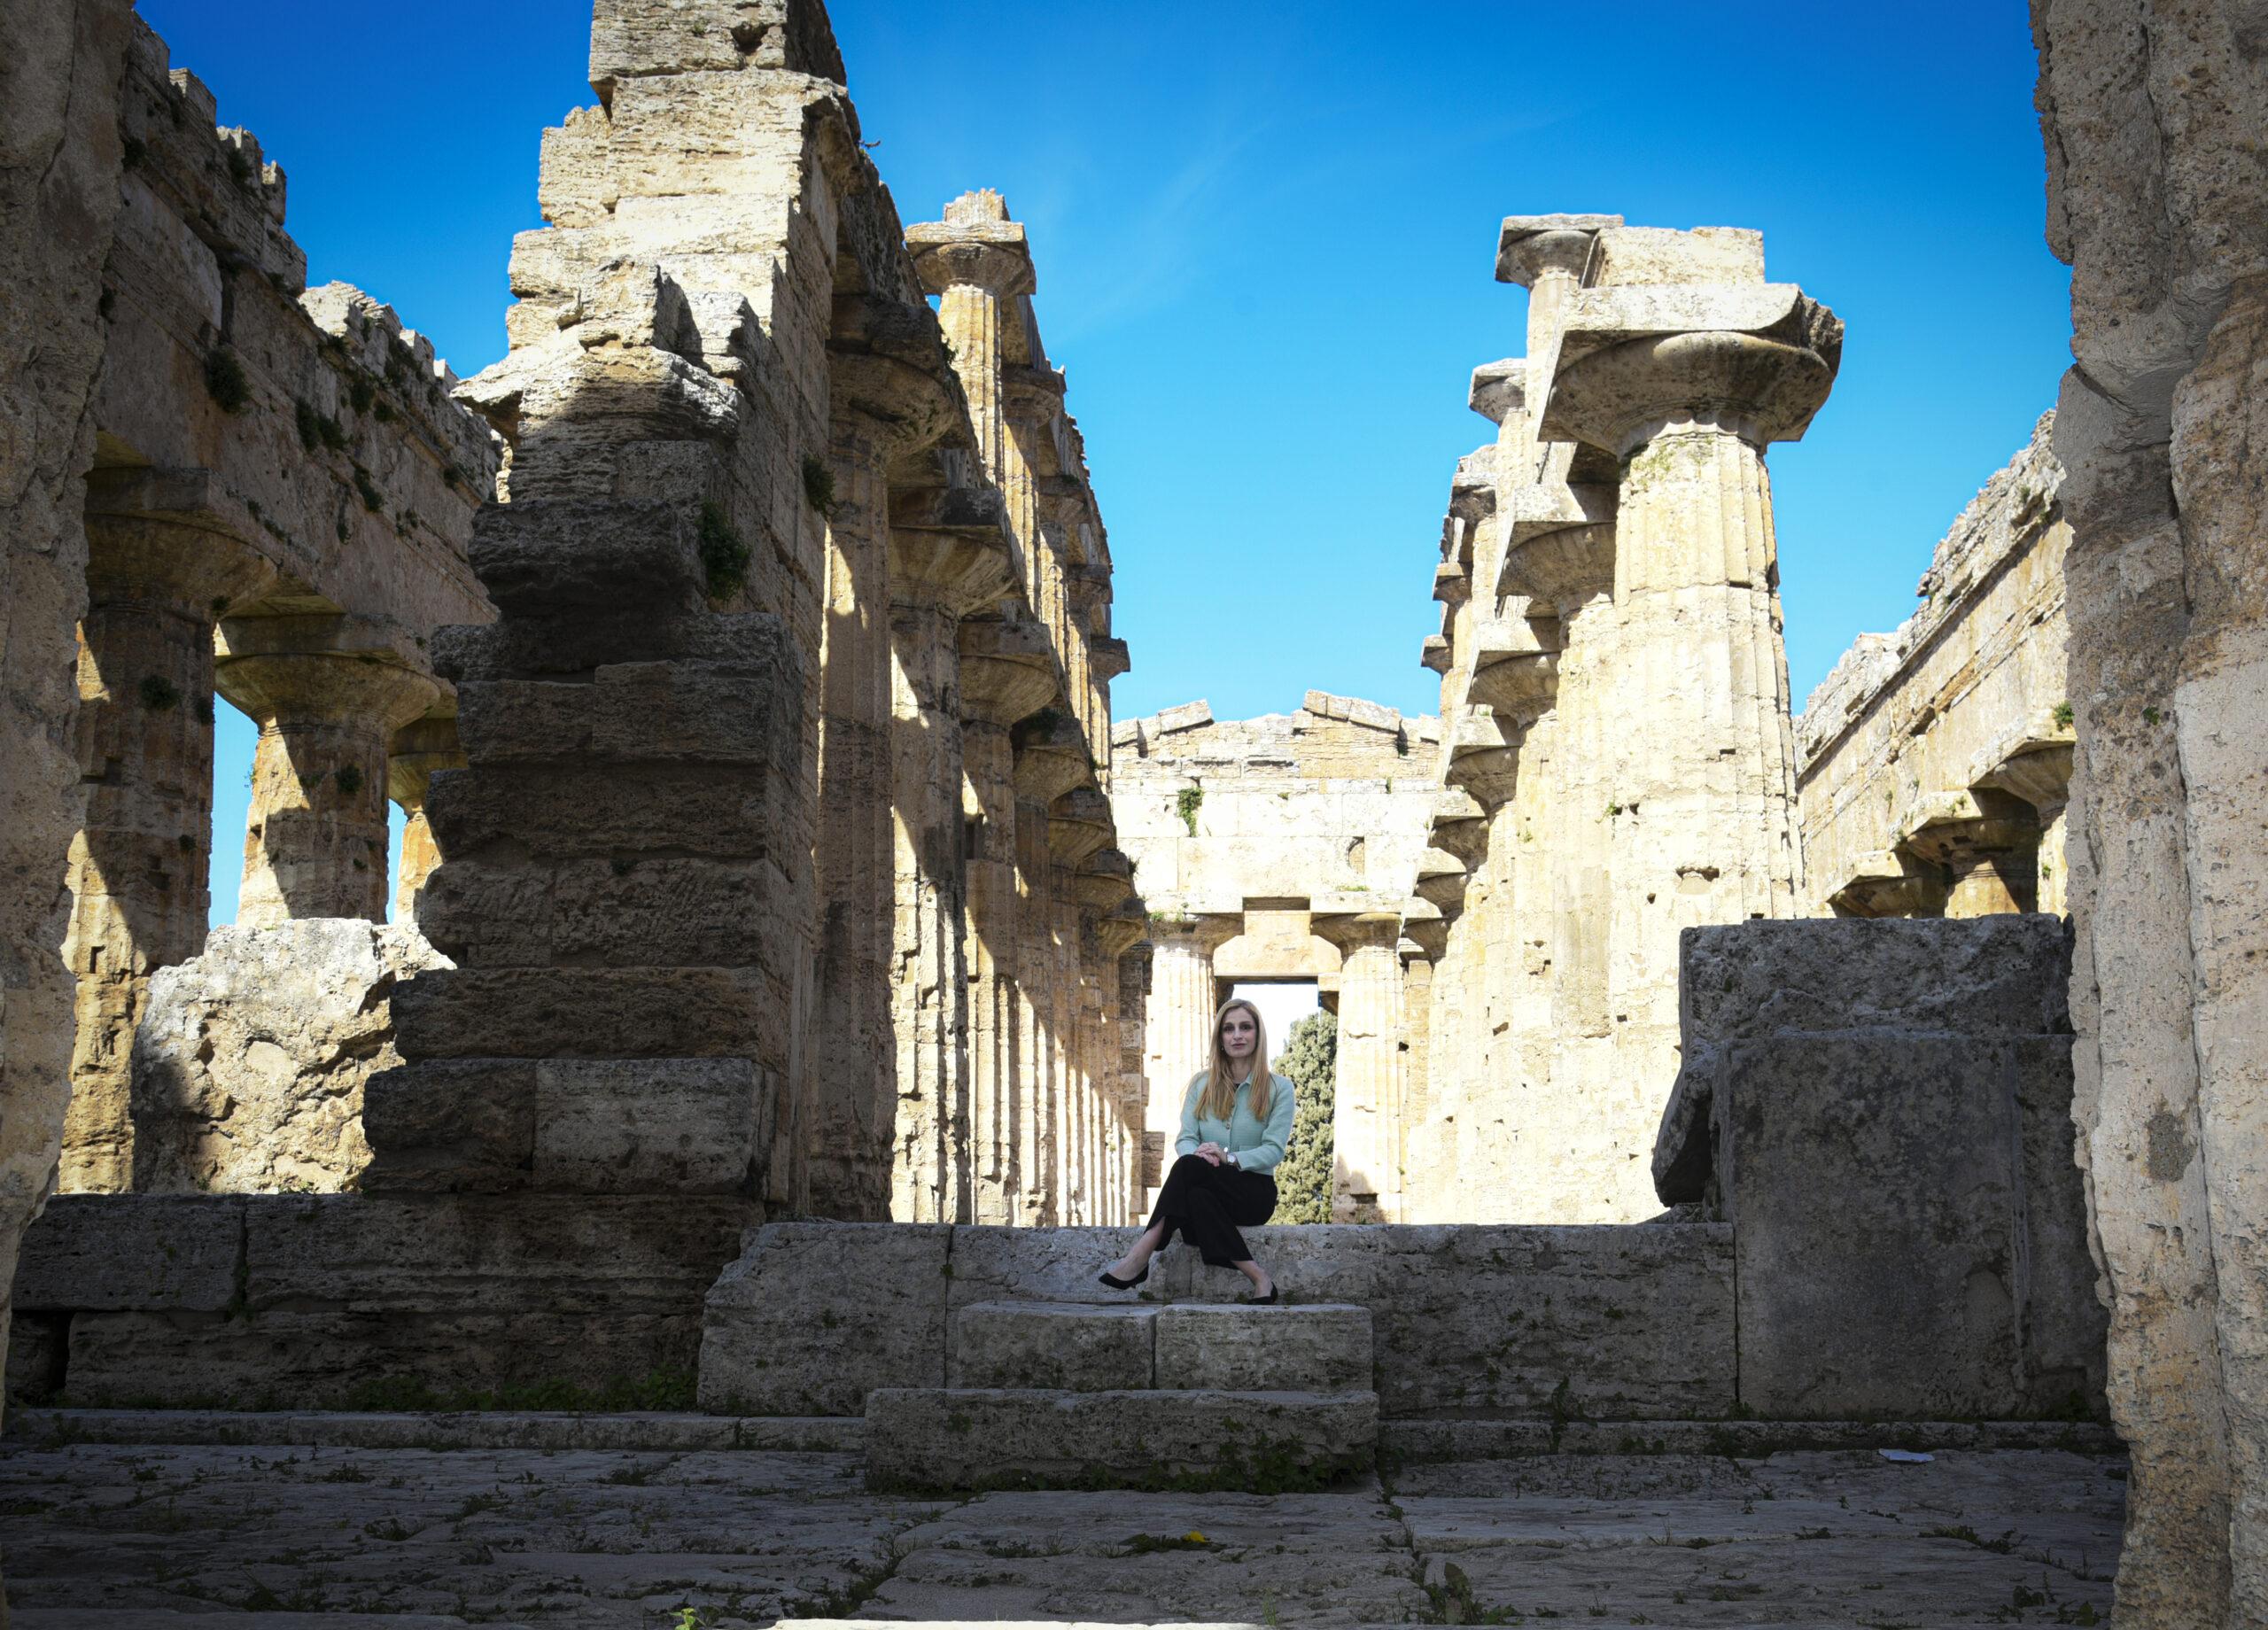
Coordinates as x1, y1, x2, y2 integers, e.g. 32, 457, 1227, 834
1313, 912, 1402, 1222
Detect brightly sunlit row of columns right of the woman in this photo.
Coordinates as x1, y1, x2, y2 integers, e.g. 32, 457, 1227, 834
1404, 215, 1842, 1222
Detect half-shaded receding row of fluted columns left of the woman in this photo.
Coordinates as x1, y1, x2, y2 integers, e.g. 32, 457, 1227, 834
812, 193, 1146, 1224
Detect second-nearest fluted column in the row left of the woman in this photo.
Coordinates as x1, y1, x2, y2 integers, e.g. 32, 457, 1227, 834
889, 485, 1012, 1222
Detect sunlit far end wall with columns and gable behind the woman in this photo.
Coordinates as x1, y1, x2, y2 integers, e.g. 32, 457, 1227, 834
1111, 692, 1441, 1222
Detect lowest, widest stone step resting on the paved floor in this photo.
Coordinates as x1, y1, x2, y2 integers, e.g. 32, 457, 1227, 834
866, 1387, 1379, 1494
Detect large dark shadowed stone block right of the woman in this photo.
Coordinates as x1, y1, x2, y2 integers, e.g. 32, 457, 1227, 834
1653, 916, 2105, 1419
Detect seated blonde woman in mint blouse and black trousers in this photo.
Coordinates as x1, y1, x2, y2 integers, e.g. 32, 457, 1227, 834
1102, 997, 1293, 1301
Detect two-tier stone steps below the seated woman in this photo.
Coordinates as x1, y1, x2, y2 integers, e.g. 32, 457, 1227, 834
866, 1301, 1379, 1494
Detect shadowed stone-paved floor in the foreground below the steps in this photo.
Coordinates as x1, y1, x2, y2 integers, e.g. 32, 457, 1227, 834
0, 1442, 2125, 1630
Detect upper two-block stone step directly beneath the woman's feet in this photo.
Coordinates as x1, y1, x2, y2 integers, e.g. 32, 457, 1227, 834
946, 1301, 1372, 1392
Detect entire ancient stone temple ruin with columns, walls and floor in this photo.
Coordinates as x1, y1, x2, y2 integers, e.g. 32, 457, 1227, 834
0, 0, 2268, 1630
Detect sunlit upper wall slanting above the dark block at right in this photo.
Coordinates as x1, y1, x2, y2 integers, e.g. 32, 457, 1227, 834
1797, 415, 2073, 916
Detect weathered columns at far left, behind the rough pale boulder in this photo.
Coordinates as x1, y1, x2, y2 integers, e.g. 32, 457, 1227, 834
59, 470, 461, 1192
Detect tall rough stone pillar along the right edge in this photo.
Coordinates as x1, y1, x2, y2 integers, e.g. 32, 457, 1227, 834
2032, 0, 2268, 1627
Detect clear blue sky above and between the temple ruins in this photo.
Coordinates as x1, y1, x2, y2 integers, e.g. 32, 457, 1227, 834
141, 0, 2069, 920
